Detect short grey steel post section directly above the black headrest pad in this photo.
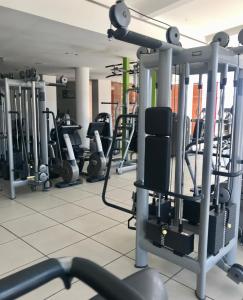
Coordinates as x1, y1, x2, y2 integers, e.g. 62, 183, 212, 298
157, 49, 172, 107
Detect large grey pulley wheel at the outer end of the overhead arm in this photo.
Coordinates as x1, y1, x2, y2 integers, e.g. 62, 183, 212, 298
109, 1, 131, 28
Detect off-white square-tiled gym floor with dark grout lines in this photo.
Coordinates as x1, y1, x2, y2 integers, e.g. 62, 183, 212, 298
0, 172, 243, 300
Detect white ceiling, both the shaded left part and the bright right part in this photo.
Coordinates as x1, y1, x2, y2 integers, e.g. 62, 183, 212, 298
0, 0, 243, 78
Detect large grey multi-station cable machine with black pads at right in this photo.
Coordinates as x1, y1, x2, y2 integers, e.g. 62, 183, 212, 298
107, 1, 243, 300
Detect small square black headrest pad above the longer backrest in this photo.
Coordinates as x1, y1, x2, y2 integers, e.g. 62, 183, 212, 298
145, 107, 172, 136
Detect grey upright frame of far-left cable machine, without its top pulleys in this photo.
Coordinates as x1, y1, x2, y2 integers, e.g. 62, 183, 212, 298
0, 78, 49, 199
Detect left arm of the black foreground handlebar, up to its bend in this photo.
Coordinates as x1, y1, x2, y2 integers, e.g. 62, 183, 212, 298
0, 259, 67, 300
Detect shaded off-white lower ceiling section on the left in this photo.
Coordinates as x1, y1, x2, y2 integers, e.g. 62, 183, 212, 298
0, 7, 137, 77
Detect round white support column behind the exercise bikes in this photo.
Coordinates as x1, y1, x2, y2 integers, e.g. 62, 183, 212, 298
75, 67, 90, 148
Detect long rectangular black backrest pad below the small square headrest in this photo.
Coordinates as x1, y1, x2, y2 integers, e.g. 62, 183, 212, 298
144, 136, 171, 194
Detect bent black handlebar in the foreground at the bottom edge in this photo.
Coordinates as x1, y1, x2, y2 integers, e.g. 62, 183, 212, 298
0, 257, 143, 300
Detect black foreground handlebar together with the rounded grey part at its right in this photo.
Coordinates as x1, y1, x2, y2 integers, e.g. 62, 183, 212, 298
0, 257, 168, 300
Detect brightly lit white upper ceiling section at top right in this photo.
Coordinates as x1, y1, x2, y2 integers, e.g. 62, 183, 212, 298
96, 0, 243, 40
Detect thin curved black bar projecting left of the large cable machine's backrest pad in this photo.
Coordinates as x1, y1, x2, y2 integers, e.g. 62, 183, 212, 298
102, 114, 138, 215
